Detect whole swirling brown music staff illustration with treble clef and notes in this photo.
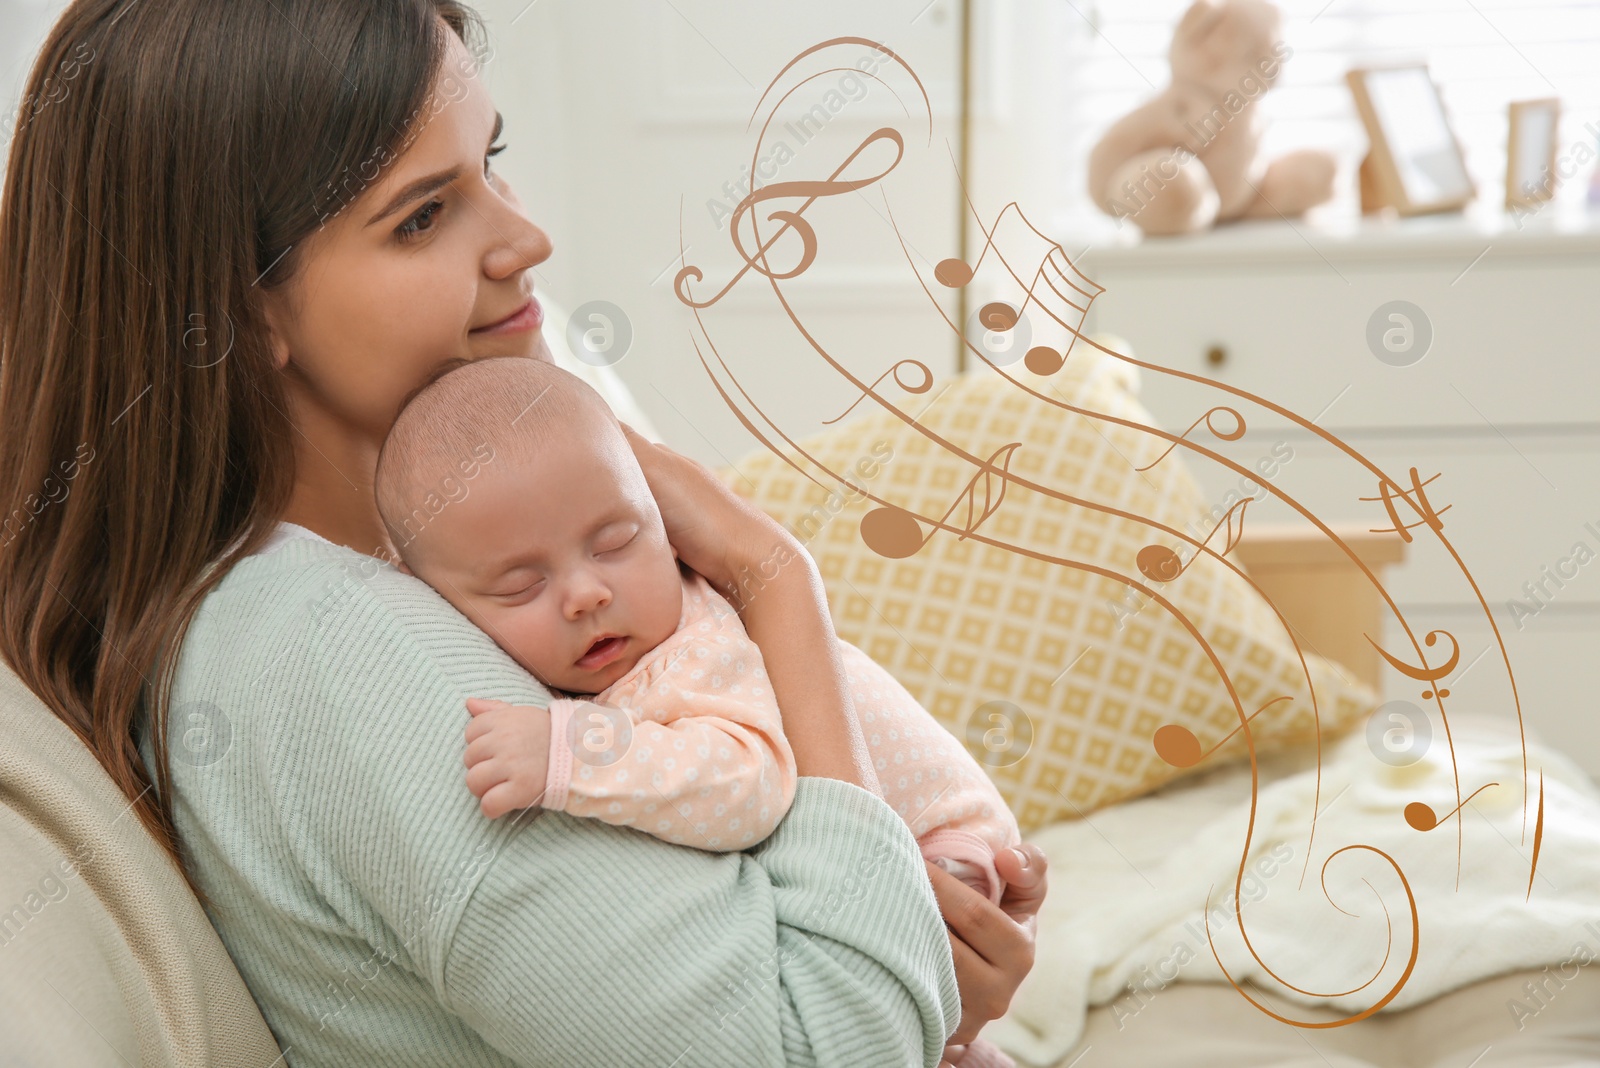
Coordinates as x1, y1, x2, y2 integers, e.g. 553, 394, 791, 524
675, 38, 1544, 1028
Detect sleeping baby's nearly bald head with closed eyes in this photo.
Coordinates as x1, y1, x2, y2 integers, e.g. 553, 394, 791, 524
376, 357, 683, 694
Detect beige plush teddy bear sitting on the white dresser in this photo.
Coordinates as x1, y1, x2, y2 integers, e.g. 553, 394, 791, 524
1088, 0, 1336, 235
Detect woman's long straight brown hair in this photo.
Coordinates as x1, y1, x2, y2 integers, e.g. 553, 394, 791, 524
0, 0, 482, 900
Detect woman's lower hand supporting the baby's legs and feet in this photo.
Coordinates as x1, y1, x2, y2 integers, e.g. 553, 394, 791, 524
925, 843, 1050, 1062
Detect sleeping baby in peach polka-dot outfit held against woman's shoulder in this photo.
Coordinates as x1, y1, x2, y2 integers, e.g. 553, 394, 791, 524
376, 357, 1021, 902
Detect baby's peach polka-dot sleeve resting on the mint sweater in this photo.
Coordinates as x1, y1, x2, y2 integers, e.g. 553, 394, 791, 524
542, 687, 795, 852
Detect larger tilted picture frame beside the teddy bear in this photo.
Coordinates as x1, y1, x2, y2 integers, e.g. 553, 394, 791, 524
1344, 64, 1477, 216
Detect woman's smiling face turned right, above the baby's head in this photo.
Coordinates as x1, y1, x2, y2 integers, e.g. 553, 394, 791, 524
266, 34, 552, 456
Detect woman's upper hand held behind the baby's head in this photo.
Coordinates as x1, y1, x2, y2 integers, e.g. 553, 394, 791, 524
618, 420, 802, 596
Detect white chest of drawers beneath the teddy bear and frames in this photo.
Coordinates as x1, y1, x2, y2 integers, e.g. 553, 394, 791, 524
1061, 206, 1600, 774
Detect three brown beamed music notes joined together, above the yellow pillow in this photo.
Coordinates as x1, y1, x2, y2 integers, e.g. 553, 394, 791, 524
933, 201, 1106, 376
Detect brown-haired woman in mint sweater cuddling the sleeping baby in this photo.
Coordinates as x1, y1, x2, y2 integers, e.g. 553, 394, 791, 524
0, 0, 1045, 1065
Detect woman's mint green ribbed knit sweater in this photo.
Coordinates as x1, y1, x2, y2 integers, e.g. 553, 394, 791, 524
141, 539, 960, 1068
